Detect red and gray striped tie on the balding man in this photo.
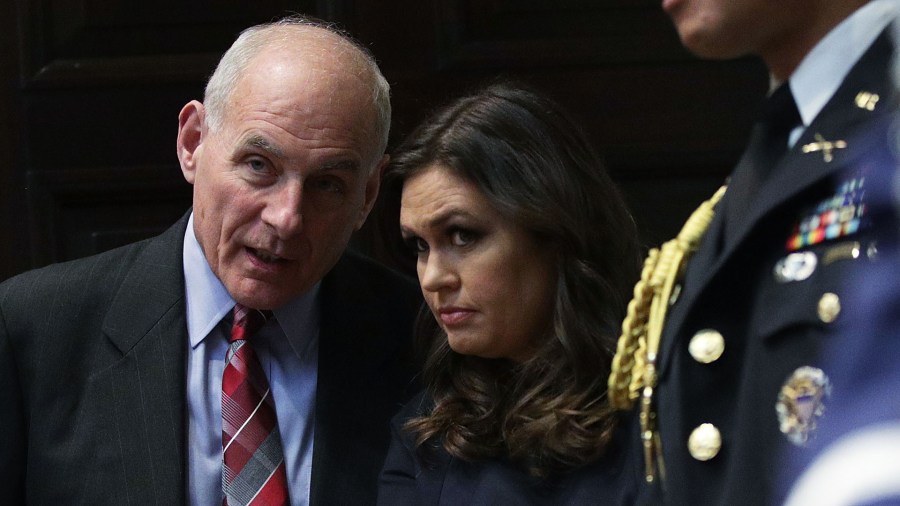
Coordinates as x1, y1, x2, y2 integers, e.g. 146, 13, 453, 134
222, 304, 290, 506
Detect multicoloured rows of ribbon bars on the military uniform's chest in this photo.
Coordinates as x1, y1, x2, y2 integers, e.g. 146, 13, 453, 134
786, 178, 868, 251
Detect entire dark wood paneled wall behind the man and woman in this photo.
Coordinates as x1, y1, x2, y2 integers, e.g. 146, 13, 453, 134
0, 0, 767, 277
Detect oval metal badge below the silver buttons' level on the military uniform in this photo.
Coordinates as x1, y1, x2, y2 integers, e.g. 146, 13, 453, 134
775, 366, 831, 446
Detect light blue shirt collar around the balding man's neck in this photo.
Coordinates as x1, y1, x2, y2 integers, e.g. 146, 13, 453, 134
182, 213, 321, 356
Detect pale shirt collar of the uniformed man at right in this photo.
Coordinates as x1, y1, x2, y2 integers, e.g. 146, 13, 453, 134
773, 0, 900, 126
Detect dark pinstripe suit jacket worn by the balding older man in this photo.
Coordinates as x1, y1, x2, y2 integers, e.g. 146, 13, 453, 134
0, 212, 421, 506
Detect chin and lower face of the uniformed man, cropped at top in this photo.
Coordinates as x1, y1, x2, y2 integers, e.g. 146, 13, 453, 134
662, 0, 812, 59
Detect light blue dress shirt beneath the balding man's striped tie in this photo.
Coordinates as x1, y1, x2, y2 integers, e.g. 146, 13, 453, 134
184, 215, 319, 506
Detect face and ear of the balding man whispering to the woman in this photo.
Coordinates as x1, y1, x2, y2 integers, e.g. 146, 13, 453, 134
179, 42, 384, 309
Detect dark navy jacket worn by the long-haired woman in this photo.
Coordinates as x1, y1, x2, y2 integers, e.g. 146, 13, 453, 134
378, 394, 630, 506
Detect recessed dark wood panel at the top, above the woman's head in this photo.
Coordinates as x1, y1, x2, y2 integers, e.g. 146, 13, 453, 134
437, 0, 686, 69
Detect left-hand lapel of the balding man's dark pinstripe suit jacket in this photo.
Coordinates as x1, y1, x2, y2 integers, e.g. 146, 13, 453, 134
98, 216, 187, 504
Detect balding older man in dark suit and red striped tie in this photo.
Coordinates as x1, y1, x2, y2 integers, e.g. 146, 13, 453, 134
0, 18, 420, 505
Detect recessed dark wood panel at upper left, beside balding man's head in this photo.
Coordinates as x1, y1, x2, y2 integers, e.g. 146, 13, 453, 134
22, 0, 315, 87
